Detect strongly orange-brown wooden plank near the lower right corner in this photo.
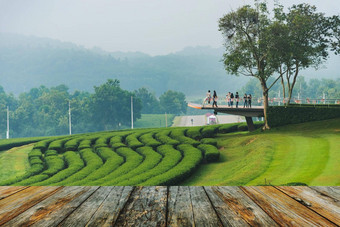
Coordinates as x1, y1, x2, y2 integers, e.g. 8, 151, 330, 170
240, 186, 335, 226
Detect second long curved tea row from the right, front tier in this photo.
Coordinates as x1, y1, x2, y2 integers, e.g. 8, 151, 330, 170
117, 145, 182, 185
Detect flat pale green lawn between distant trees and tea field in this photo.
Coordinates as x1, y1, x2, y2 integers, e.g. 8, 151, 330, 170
134, 114, 175, 128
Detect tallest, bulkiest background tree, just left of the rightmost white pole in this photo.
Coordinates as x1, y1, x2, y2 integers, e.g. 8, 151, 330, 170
90, 79, 142, 130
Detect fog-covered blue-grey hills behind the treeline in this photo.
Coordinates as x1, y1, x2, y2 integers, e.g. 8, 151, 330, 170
0, 33, 340, 96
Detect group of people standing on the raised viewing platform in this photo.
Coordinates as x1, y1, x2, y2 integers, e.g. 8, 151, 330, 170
203, 90, 252, 108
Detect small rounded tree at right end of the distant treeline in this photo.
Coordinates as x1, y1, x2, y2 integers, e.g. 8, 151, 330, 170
159, 90, 188, 114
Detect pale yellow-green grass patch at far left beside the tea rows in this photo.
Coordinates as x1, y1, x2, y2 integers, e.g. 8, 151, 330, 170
0, 145, 33, 181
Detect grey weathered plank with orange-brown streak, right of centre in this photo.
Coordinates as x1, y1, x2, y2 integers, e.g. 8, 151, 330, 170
205, 187, 277, 226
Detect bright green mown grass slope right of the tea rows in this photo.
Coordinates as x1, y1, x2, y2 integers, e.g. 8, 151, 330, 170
183, 119, 340, 185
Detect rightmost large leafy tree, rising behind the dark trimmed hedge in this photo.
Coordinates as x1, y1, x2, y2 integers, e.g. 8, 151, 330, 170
270, 4, 334, 104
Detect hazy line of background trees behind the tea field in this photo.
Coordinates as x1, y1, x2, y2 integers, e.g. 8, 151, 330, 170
0, 79, 187, 138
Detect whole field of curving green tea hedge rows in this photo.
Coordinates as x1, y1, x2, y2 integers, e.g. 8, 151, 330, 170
0, 124, 252, 185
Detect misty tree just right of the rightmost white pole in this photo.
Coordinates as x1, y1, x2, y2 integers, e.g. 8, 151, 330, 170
134, 87, 160, 114
